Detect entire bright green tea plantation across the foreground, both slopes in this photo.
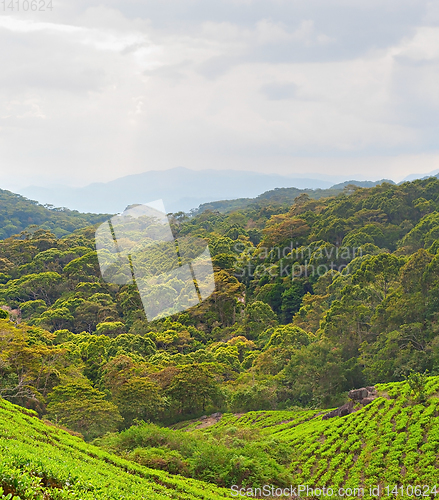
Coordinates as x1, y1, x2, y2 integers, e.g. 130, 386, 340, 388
0, 376, 439, 500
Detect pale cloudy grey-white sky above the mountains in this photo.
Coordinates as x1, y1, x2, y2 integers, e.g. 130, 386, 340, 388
0, 0, 439, 190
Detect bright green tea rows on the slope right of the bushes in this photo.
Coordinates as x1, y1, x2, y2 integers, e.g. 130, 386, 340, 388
194, 377, 439, 494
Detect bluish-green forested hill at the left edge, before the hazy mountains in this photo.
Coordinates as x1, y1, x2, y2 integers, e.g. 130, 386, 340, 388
0, 189, 108, 239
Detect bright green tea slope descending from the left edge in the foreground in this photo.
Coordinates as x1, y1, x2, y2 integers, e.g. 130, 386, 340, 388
0, 399, 230, 500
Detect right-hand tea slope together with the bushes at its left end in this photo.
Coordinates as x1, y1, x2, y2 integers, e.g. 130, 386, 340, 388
99, 377, 439, 498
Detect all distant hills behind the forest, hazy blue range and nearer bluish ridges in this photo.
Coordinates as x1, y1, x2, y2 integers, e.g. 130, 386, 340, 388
0, 168, 439, 240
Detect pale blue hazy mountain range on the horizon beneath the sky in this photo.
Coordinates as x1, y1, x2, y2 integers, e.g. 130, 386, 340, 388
19, 167, 398, 213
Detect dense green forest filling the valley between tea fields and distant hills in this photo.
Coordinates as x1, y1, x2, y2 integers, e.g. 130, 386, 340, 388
0, 178, 439, 492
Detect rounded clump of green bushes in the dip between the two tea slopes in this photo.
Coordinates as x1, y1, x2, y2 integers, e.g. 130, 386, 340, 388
94, 422, 291, 487
